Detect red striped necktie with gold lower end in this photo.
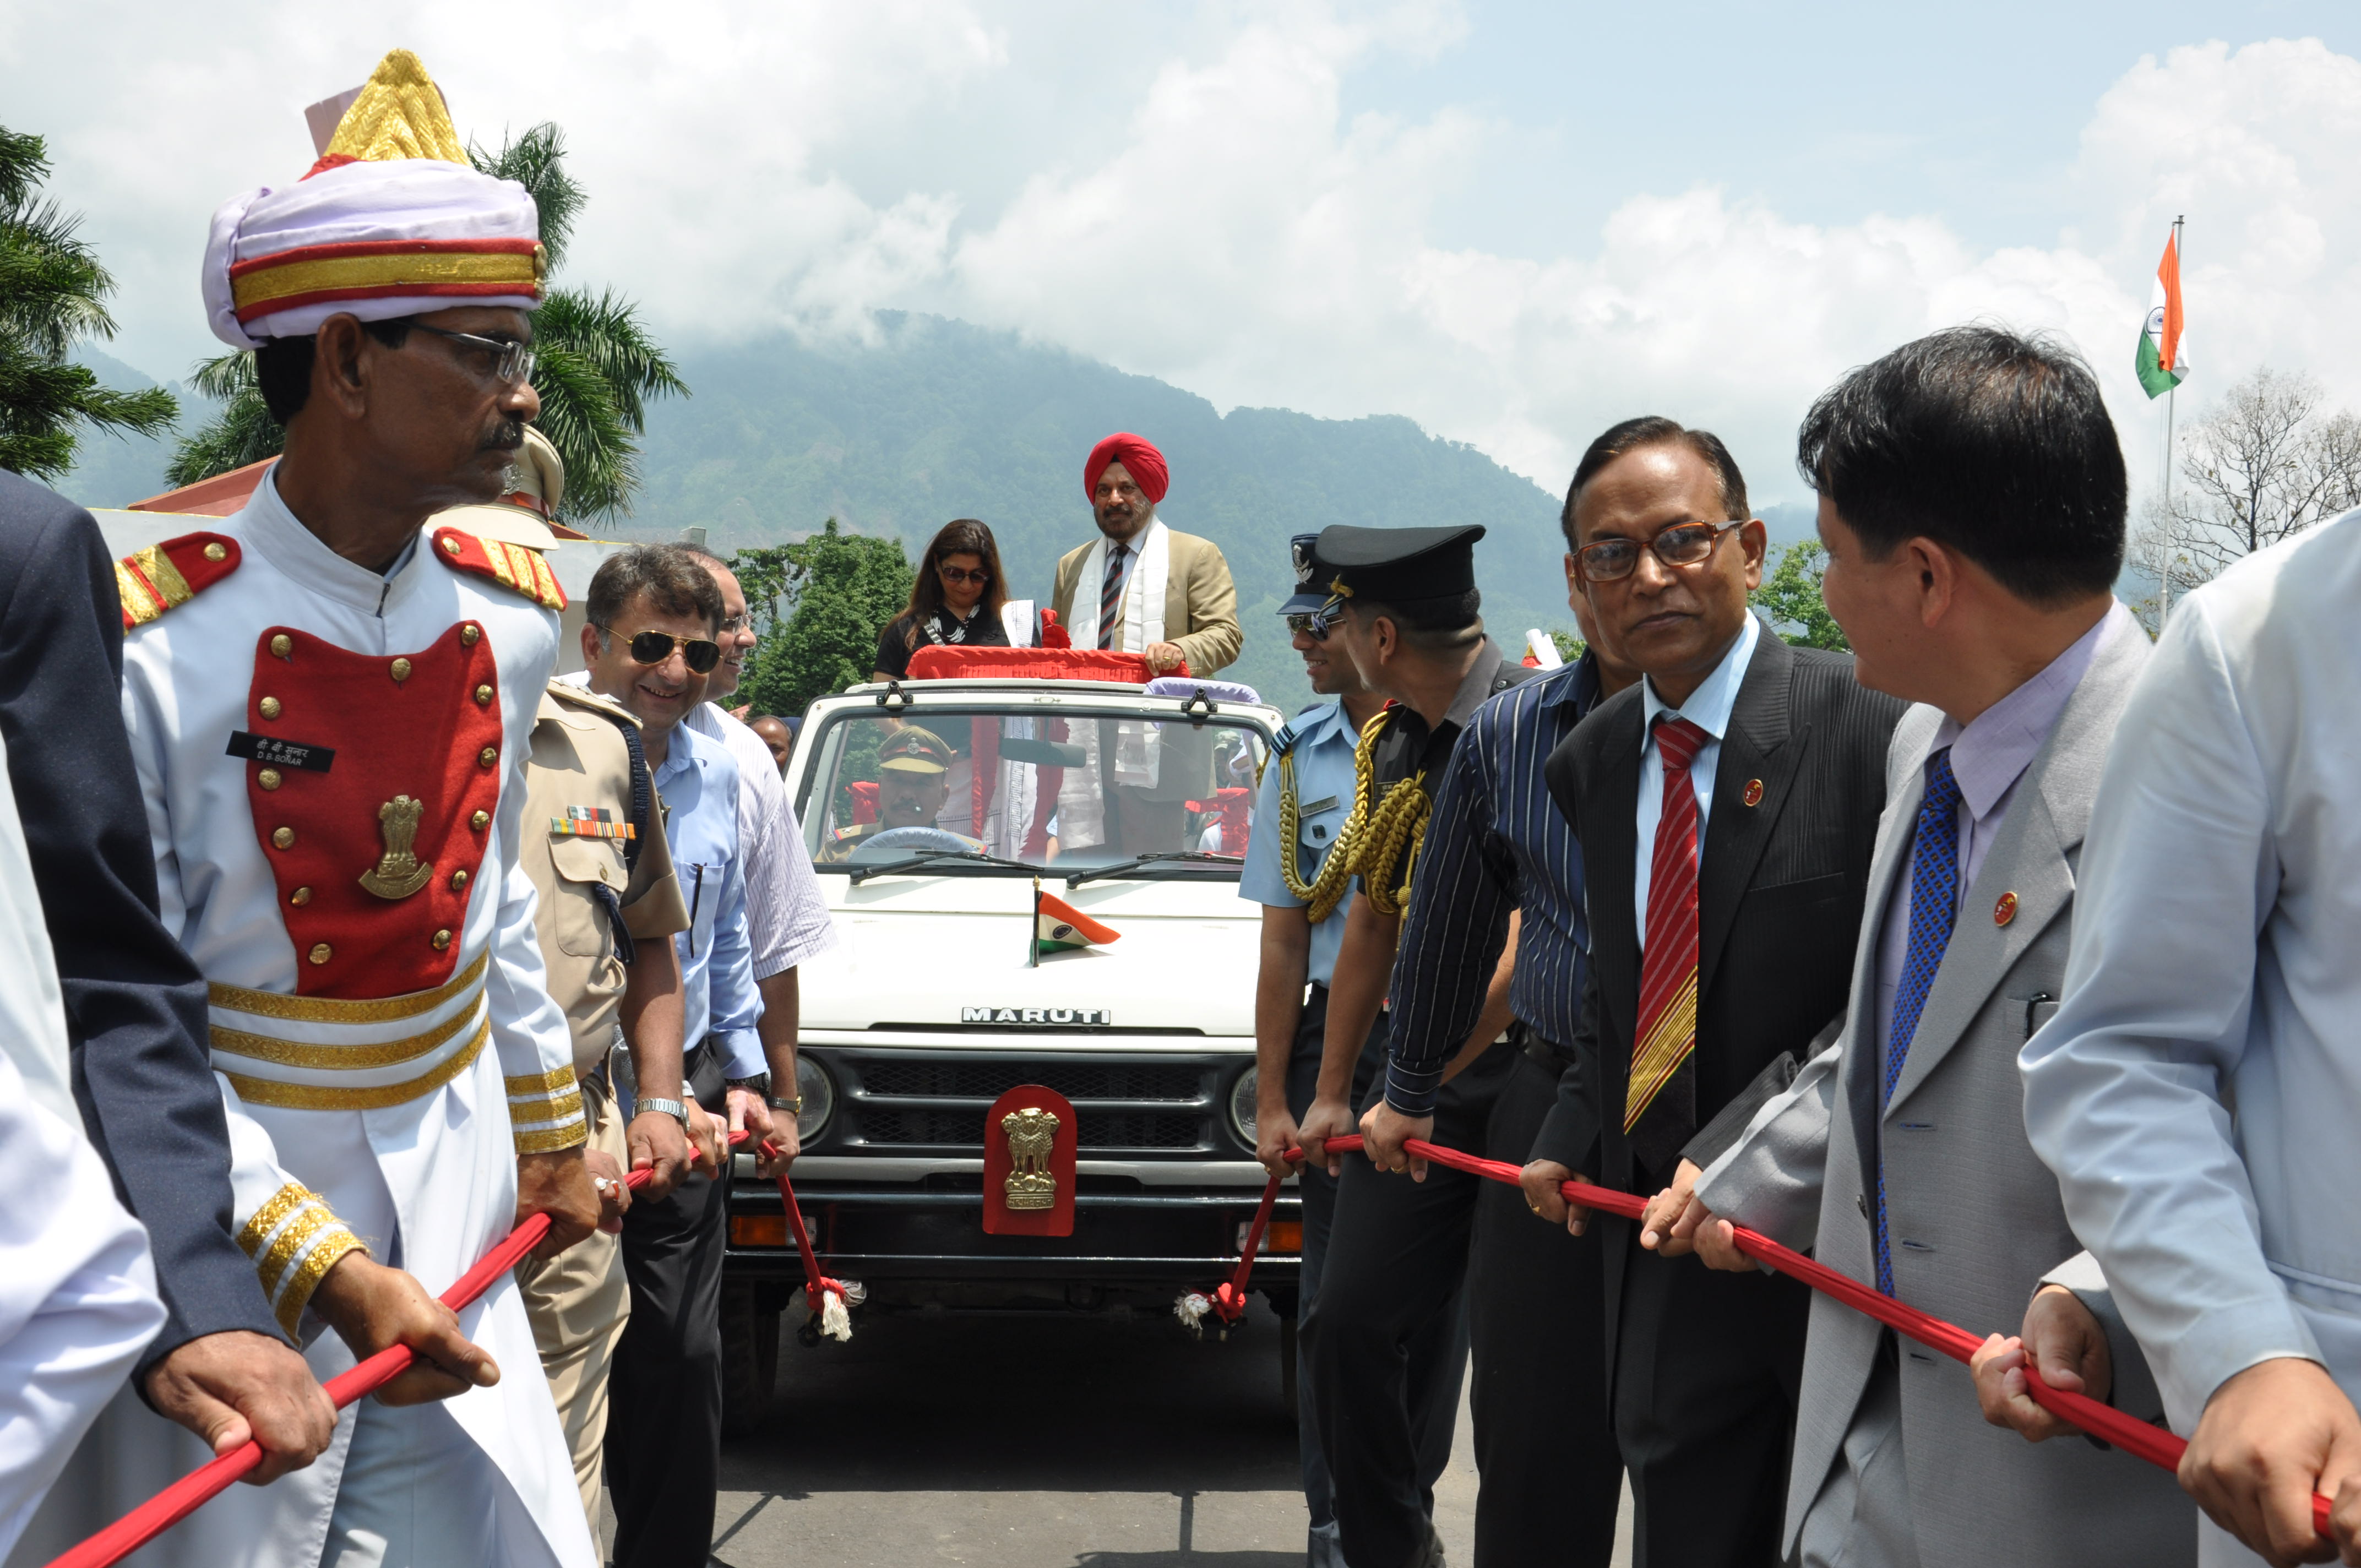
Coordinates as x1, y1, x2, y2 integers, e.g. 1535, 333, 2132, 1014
1624, 716, 1710, 1176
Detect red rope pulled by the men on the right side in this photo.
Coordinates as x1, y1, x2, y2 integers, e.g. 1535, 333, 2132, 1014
1173, 1134, 2328, 1537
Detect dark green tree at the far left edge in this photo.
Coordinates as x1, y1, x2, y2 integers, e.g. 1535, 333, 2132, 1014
0, 128, 179, 480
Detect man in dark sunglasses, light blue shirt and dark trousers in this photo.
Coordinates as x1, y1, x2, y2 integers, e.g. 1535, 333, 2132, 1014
583, 546, 772, 1568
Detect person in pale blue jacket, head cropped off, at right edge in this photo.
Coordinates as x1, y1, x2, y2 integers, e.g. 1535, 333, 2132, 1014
2019, 513, 2361, 1568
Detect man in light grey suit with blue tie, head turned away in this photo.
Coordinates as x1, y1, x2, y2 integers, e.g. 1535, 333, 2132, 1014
1643, 326, 2196, 1568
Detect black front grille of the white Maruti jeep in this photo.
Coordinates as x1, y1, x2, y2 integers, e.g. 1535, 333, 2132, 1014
817, 1051, 1239, 1155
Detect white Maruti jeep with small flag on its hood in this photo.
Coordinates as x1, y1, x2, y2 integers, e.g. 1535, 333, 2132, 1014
722, 678, 1301, 1429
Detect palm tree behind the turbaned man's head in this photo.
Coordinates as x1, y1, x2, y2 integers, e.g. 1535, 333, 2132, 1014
167, 125, 689, 524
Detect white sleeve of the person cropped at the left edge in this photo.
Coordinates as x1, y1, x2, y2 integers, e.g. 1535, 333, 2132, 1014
0, 727, 165, 1556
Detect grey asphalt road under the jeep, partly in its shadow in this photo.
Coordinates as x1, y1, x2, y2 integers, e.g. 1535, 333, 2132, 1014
651, 1301, 1629, 1568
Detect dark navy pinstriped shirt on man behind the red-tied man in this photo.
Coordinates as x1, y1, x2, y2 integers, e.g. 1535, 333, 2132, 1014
1386, 654, 1598, 1117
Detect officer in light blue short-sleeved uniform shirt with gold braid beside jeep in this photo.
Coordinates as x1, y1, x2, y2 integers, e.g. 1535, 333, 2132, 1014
1237, 533, 1457, 1568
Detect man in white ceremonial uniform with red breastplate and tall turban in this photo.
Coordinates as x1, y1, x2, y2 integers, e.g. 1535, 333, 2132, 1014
11, 52, 600, 1568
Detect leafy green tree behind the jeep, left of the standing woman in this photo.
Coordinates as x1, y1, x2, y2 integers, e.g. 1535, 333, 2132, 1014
730, 517, 911, 713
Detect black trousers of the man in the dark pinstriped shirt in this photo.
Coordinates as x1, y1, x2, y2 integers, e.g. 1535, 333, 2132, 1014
1473, 1030, 1622, 1568
